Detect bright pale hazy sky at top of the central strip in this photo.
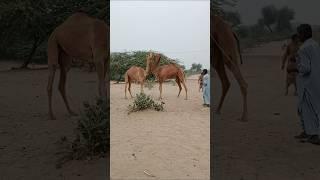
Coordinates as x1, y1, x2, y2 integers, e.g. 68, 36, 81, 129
110, 0, 210, 68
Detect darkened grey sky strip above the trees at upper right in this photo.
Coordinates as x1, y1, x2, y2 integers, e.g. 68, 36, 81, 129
229, 0, 320, 25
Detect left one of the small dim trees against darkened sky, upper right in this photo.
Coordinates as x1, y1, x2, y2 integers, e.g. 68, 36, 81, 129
261, 5, 277, 32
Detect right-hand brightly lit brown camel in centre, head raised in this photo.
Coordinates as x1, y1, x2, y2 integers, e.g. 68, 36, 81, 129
147, 52, 188, 100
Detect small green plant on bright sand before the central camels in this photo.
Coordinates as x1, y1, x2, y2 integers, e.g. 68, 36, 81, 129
129, 93, 164, 113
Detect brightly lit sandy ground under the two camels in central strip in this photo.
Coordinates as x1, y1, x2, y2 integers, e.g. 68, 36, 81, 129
111, 76, 210, 180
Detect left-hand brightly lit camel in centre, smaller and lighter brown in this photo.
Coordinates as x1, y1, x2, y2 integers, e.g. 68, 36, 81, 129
124, 66, 147, 99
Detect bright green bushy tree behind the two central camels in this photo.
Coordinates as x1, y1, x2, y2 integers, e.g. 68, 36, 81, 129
110, 51, 179, 81
